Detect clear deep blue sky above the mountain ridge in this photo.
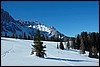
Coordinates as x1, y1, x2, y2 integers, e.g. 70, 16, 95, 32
1, 1, 99, 37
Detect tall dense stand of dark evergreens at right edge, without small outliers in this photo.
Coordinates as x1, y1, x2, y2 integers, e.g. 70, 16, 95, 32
73, 32, 99, 58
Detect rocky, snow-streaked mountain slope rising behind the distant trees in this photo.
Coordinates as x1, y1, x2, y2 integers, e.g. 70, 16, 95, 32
1, 9, 68, 40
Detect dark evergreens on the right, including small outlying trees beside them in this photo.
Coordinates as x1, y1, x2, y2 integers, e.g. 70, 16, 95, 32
57, 32, 99, 58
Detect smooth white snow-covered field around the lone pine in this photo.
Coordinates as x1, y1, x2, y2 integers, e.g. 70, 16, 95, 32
1, 37, 99, 66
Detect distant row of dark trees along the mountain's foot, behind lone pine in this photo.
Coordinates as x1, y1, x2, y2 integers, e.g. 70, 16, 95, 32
1, 32, 61, 42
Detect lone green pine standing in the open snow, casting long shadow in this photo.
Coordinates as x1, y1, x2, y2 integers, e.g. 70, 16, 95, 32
31, 30, 46, 58
